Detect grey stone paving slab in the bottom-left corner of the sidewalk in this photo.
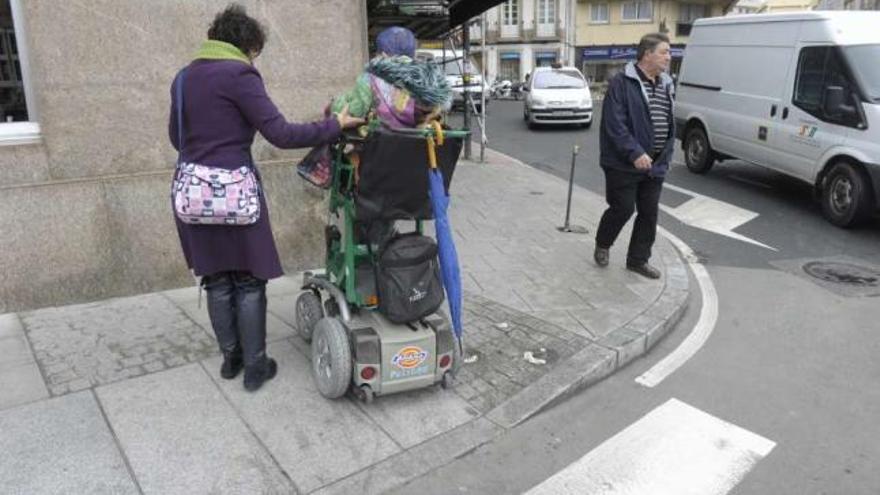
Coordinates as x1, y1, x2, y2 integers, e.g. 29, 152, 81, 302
0, 389, 139, 494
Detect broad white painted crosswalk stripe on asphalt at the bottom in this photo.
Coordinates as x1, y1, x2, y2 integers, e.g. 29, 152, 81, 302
526, 399, 776, 495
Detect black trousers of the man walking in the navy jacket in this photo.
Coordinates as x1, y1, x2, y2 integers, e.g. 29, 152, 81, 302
596, 168, 663, 265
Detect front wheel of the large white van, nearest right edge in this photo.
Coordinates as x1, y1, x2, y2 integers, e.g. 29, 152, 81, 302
822, 162, 873, 228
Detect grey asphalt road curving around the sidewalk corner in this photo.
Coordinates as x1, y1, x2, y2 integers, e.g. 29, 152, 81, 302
397, 101, 880, 495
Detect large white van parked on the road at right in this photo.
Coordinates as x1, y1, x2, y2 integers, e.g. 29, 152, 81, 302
675, 11, 880, 227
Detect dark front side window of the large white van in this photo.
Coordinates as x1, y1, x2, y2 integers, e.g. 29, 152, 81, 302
792, 46, 860, 127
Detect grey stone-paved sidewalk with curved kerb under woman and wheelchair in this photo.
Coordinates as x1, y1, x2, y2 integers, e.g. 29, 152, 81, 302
0, 148, 689, 495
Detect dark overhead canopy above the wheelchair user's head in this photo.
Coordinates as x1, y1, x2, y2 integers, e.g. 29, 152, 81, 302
366, 0, 504, 39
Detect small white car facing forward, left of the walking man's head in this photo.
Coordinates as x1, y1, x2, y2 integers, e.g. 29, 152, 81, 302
523, 67, 593, 128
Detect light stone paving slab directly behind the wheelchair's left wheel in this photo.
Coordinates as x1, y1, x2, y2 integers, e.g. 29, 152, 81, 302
205, 342, 402, 493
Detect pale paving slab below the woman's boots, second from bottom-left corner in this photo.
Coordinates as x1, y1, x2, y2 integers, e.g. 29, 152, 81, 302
97, 364, 295, 495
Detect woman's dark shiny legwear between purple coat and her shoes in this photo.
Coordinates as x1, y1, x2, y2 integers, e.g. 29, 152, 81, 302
202, 271, 267, 366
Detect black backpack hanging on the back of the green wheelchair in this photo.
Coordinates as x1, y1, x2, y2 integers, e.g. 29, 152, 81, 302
376, 233, 444, 323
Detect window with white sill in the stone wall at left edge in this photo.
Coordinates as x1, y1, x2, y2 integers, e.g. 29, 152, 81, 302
0, 0, 40, 145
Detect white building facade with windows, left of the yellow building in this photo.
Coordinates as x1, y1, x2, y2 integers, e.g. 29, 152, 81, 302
470, 0, 575, 81
